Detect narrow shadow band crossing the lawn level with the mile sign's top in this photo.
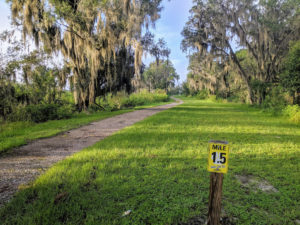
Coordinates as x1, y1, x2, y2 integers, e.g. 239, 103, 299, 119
112, 130, 300, 146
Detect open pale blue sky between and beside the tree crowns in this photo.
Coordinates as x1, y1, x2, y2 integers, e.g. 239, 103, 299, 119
0, 0, 193, 82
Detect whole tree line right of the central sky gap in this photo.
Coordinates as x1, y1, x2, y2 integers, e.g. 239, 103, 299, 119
181, 0, 300, 104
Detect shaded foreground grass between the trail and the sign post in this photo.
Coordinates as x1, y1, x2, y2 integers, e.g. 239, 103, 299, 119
0, 153, 208, 224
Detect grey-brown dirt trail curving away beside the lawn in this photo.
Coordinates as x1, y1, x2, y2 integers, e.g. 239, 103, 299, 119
0, 99, 182, 207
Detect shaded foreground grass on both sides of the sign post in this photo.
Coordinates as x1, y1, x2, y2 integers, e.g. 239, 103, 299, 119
0, 149, 299, 224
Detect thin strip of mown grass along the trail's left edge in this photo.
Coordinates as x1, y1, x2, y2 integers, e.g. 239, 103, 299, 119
0, 99, 173, 155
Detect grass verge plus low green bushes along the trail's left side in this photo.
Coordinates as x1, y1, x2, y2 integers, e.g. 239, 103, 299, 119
0, 90, 170, 154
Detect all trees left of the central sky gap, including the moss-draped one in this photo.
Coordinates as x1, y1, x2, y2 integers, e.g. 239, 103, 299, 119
0, 0, 178, 121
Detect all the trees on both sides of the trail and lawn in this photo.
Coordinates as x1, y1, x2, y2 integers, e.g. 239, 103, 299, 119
0, 0, 300, 121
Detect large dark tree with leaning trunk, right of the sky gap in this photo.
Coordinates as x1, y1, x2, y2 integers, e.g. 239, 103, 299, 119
182, 0, 300, 103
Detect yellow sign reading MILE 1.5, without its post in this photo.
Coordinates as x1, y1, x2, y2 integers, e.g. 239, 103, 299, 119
207, 141, 229, 173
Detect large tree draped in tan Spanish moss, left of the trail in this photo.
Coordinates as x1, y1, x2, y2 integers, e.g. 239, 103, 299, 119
8, 0, 162, 109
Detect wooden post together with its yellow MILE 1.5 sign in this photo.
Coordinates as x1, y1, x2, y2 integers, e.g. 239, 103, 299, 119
207, 141, 229, 225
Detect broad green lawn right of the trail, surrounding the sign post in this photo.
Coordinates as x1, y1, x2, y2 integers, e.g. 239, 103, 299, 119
0, 100, 300, 225
